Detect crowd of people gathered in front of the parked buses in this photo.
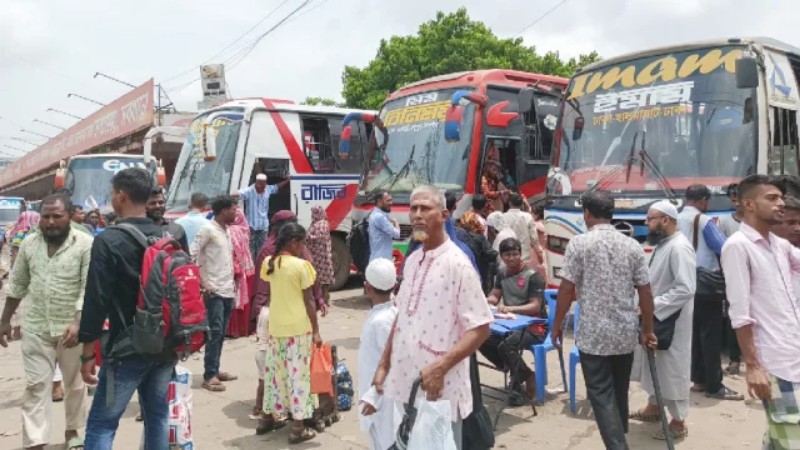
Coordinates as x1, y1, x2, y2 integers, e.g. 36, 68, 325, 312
0, 165, 800, 450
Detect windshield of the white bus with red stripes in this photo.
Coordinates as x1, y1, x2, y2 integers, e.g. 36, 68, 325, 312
166, 110, 244, 213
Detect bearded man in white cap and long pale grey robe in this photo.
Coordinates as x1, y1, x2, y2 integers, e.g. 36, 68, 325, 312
631, 200, 696, 440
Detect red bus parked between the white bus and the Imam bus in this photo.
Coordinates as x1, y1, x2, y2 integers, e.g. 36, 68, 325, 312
353, 69, 567, 254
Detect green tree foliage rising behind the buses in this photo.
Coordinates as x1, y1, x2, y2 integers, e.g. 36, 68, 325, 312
342, 8, 600, 109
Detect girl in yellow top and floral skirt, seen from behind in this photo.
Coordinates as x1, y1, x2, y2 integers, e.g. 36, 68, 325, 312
259, 223, 322, 444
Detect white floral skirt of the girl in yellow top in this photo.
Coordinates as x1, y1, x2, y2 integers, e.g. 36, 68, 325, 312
264, 334, 316, 420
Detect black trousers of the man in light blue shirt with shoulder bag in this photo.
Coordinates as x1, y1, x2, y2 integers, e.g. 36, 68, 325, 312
692, 297, 723, 394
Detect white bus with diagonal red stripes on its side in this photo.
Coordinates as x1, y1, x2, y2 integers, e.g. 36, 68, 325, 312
166, 98, 375, 289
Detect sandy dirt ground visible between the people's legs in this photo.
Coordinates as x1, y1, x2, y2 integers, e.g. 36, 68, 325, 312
0, 250, 765, 450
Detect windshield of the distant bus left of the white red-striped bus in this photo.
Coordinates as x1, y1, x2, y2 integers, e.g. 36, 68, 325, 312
64, 156, 147, 213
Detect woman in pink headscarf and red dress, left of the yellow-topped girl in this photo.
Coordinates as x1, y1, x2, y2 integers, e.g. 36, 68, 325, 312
225, 209, 256, 337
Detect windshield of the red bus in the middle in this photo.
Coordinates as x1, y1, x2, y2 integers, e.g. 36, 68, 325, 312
362, 89, 475, 201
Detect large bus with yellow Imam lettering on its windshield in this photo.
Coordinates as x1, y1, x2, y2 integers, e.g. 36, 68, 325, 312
545, 38, 800, 286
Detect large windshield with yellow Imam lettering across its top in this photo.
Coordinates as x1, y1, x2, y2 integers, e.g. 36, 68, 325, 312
548, 46, 758, 195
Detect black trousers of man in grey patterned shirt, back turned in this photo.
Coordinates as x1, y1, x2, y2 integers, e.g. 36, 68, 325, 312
581, 352, 633, 450
